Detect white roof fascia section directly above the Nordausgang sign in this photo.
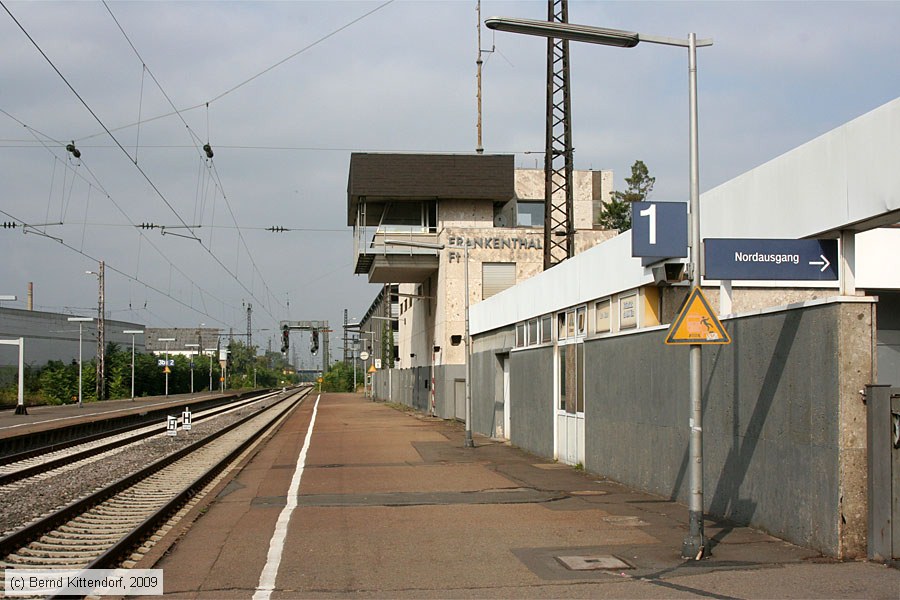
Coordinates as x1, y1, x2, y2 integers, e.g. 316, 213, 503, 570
700, 98, 900, 238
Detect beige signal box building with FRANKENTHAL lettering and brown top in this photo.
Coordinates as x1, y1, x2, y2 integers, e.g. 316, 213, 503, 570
347, 153, 614, 418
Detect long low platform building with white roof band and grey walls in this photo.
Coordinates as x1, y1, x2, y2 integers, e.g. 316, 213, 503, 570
471, 99, 900, 560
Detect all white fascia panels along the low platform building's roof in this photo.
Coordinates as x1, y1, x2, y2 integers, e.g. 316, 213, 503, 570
469, 98, 900, 335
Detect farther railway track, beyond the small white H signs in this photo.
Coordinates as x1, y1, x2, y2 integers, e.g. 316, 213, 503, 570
0, 392, 278, 492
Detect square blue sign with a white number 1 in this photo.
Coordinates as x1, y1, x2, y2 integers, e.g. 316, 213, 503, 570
631, 202, 687, 266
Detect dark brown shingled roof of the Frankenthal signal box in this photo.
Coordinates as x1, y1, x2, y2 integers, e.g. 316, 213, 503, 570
347, 153, 515, 225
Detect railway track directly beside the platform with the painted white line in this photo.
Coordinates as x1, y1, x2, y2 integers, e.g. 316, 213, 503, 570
0, 388, 311, 569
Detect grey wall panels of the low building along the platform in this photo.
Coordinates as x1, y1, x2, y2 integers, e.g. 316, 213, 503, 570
473, 298, 875, 557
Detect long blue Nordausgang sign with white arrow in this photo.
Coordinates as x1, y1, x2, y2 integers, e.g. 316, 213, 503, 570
703, 238, 838, 281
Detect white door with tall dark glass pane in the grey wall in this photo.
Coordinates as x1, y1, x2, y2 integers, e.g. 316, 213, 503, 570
556, 341, 584, 465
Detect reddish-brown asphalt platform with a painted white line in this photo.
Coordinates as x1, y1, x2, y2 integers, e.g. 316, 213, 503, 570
136, 394, 900, 599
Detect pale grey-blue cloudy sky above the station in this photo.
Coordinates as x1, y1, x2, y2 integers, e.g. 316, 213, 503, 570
0, 0, 900, 364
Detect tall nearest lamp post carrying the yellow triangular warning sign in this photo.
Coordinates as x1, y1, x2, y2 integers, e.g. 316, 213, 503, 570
484, 17, 713, 559
